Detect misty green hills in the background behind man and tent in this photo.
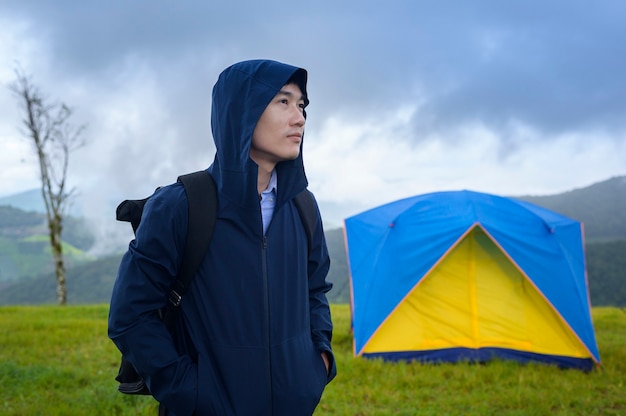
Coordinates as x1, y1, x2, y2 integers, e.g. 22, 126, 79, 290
0, 177, 626, 307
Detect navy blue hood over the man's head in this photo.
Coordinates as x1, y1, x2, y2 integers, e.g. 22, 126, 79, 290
209, 60, 308, 207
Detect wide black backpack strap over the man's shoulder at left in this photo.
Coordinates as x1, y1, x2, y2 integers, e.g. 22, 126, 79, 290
169, 170, 217, 307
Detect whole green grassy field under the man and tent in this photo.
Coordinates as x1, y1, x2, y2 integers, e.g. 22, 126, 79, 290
0, 305, 626, 416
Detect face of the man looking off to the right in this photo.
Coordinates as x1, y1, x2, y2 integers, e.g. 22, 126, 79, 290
250, 84, 305, 171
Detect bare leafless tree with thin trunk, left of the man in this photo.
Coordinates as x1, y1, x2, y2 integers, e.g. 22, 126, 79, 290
9, 69, 86, 305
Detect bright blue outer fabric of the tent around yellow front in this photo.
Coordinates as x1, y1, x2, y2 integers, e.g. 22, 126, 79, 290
345, 191, 600, 362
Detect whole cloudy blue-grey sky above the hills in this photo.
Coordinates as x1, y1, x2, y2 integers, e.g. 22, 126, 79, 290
0, 0, 626, 229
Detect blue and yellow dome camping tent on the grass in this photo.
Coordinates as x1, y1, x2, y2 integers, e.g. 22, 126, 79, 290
345, 191, 600, 370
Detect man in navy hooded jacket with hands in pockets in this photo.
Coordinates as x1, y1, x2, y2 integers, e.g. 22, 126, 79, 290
109, 60, 336, 416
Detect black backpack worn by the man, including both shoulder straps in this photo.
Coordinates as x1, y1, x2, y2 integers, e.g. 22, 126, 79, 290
115, 170, 317, 395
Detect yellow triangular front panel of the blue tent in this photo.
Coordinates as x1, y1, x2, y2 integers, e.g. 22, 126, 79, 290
362, 226, 590, 358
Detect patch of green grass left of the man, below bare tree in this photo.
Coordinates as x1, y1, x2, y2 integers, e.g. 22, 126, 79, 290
0, 306, 156, 415
